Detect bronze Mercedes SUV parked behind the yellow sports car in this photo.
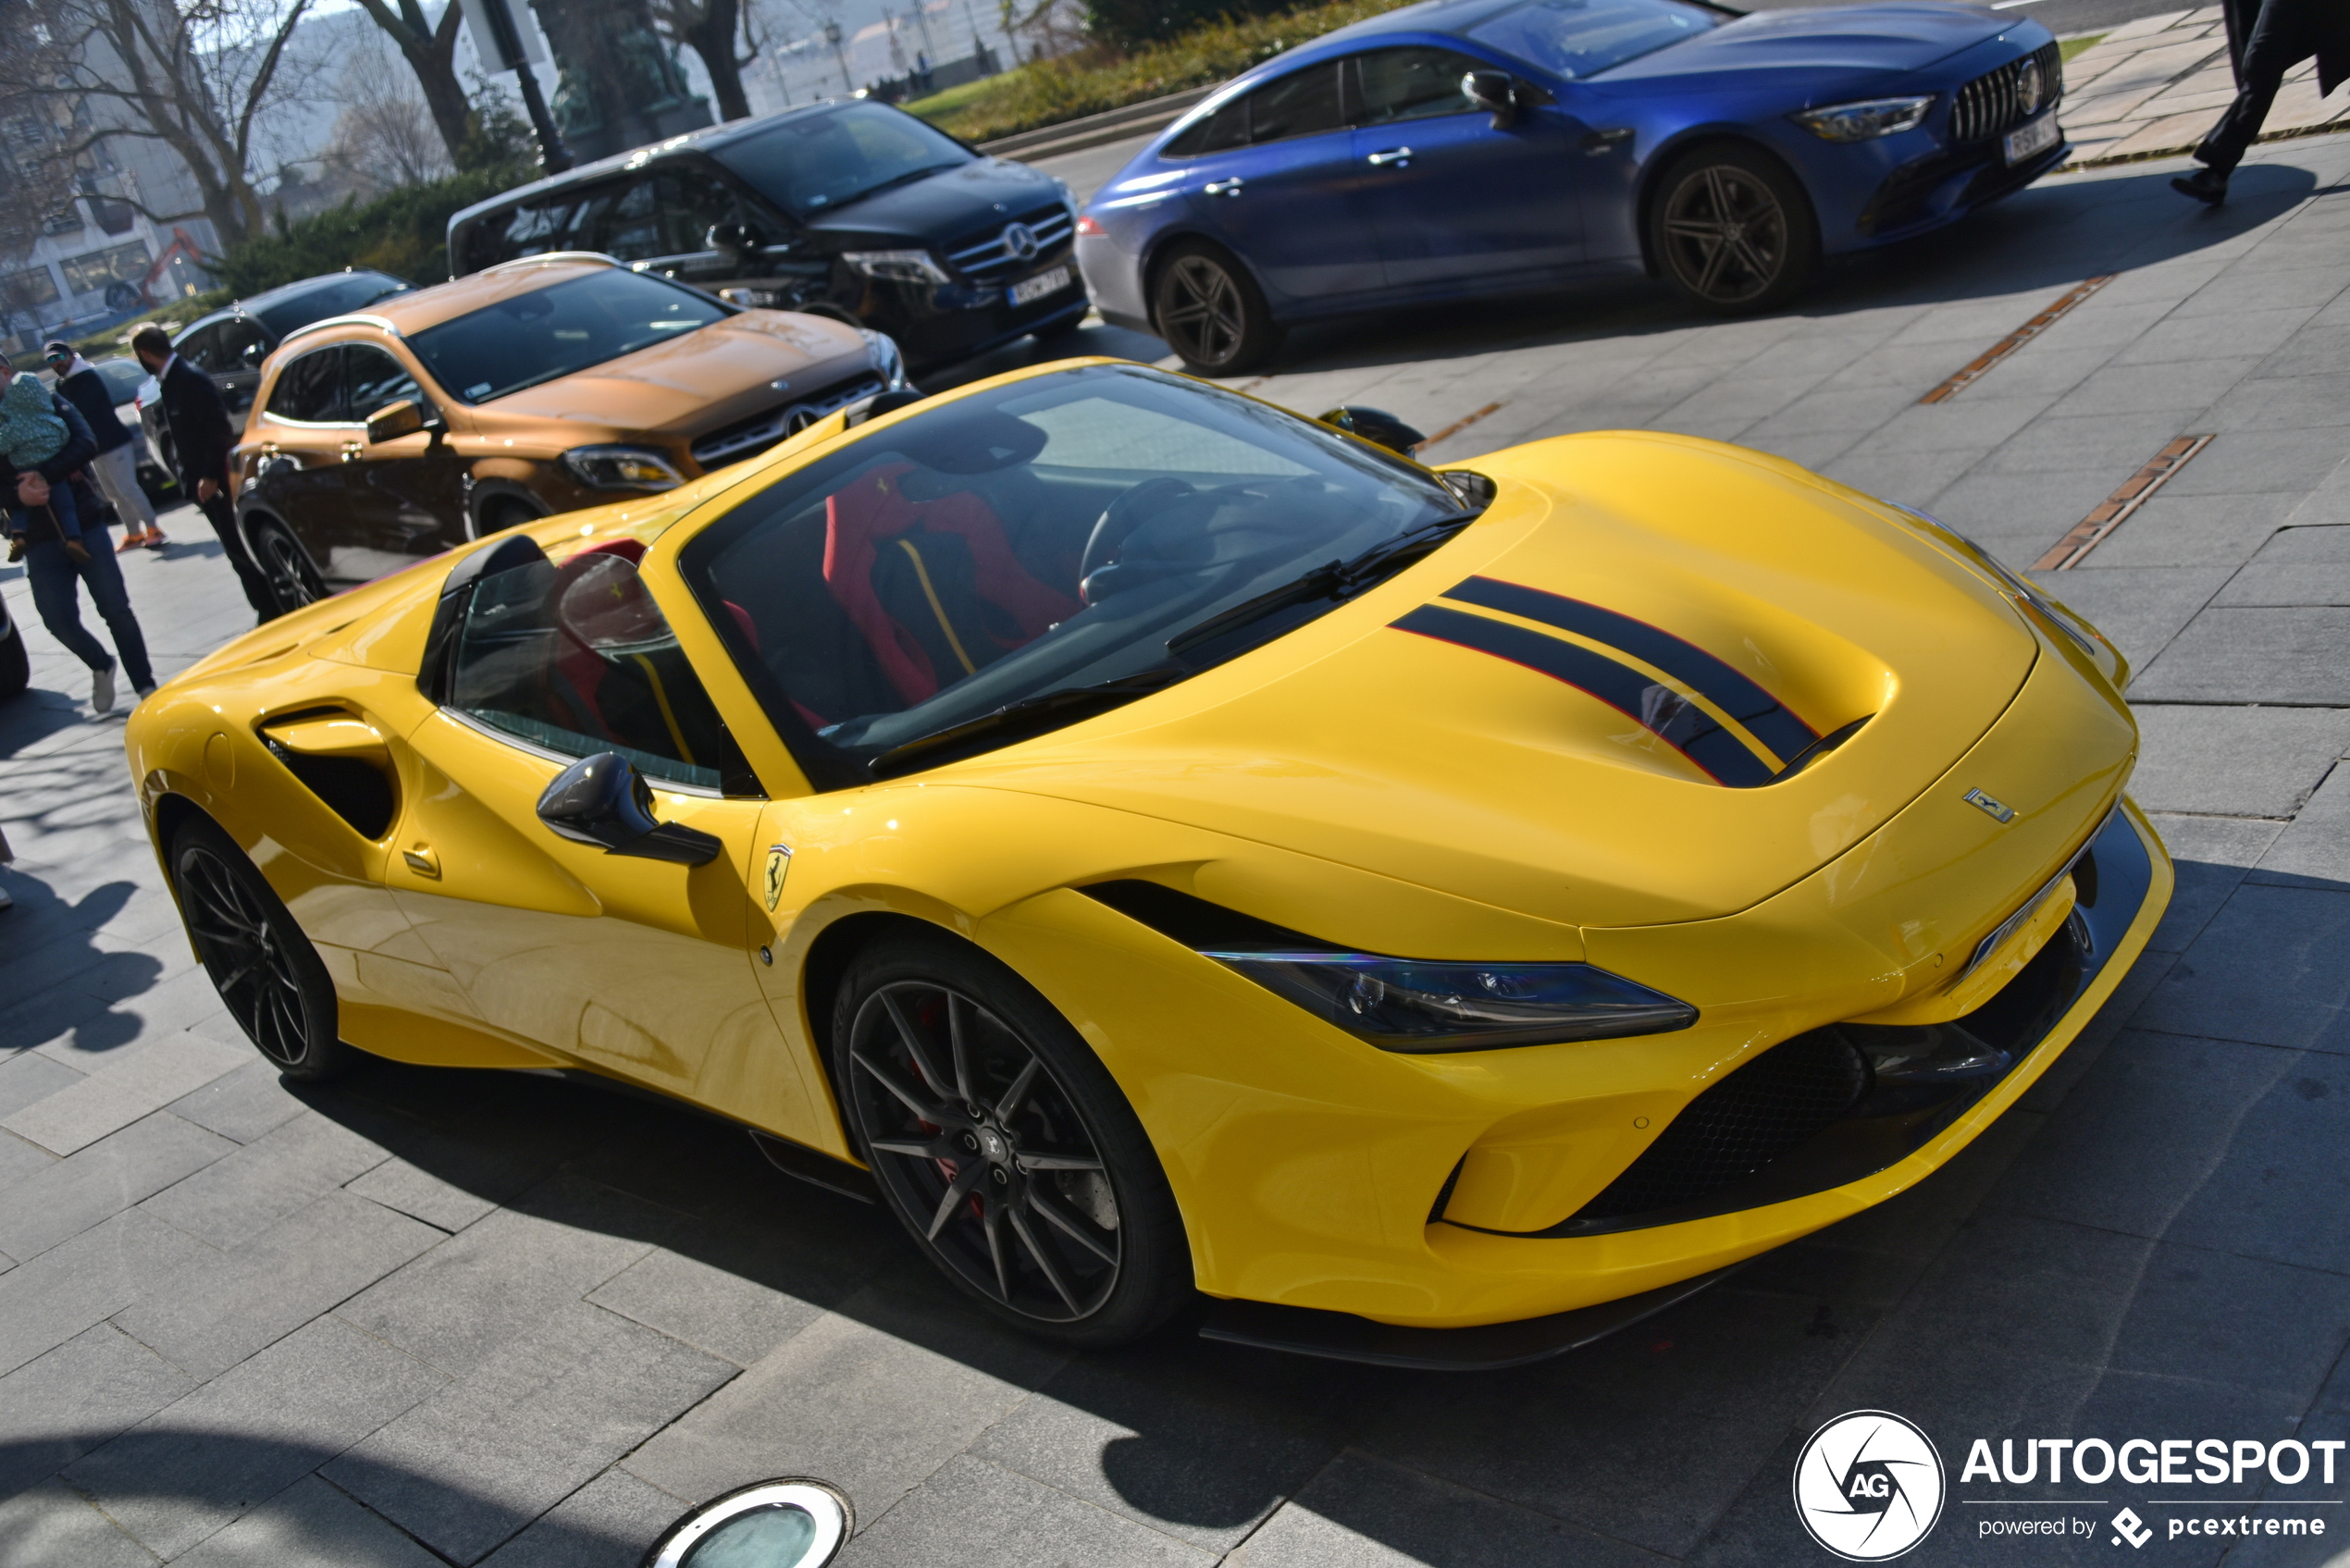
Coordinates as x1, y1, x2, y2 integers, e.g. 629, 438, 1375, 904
235, 253, 907, 609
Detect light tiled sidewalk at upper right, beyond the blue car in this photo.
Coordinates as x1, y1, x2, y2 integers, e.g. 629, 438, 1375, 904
2063, 5, 2350, 167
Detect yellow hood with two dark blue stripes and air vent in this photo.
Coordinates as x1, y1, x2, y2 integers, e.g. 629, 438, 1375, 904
954, 433, 2048, 940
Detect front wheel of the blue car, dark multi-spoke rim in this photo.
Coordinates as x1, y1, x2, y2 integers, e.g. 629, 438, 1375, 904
1650, 146, 1819, 315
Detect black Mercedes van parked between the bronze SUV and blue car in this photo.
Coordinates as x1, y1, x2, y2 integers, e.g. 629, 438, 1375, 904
449, 99, 1088, 366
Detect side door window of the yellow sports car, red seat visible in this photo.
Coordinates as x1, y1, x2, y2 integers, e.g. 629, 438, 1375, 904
449, 546, 748, 790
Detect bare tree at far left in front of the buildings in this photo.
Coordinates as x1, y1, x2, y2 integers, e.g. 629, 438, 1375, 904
0, 0, 310, 249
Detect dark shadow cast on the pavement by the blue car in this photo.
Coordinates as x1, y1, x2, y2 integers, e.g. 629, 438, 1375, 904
1241, 162, 2317, 377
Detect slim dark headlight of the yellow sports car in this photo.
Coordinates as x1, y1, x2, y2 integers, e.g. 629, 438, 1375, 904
1201, 950, 1697, 1053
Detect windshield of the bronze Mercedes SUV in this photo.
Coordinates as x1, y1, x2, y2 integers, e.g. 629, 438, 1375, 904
409, 268, 726, 402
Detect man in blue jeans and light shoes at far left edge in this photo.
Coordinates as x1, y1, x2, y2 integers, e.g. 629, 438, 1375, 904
0, 355, 155, 712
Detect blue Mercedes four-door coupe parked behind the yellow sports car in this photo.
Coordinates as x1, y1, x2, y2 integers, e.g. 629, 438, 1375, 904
1076, 0, 2066, 374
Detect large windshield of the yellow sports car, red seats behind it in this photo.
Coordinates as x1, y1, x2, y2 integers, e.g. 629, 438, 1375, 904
684, 364, 1462, 773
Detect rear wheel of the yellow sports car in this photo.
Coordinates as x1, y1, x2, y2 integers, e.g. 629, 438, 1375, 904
171, 818, 357, 1084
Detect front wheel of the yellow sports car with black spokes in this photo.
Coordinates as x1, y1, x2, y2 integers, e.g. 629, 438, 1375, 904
832, 935, 1192, 1347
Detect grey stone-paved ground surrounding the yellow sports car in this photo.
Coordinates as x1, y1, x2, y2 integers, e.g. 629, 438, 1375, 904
0, 139, 2350, 1568
